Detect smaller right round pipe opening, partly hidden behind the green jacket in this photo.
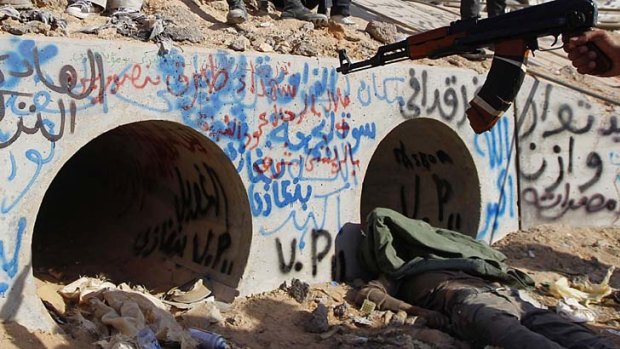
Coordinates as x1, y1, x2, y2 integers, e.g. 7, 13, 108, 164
360, 118, 481, 238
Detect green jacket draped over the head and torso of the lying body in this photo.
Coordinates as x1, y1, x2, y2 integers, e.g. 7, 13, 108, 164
360, 208, 534, 288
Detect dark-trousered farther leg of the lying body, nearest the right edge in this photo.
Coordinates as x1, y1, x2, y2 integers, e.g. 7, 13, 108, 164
522, 307, 617, 349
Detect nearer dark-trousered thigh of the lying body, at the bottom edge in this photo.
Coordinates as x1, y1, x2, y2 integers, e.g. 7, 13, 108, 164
451, 292, 563, 349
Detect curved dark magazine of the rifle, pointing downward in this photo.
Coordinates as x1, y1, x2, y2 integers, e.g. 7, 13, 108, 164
465, 39, 529, 133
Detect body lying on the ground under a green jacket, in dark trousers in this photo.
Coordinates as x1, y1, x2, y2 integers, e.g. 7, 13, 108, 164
356, 209, 616, 349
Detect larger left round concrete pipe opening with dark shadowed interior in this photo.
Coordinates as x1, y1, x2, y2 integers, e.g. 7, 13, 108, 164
32, 121, 252, 300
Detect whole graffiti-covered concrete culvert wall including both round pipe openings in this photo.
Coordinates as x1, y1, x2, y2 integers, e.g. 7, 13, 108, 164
0, 36, 620, 329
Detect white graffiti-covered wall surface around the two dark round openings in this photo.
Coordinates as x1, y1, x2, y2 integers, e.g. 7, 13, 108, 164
0, 36, 620, 329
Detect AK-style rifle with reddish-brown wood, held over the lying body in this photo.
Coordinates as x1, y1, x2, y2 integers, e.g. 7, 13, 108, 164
336, 0, 612, 133
